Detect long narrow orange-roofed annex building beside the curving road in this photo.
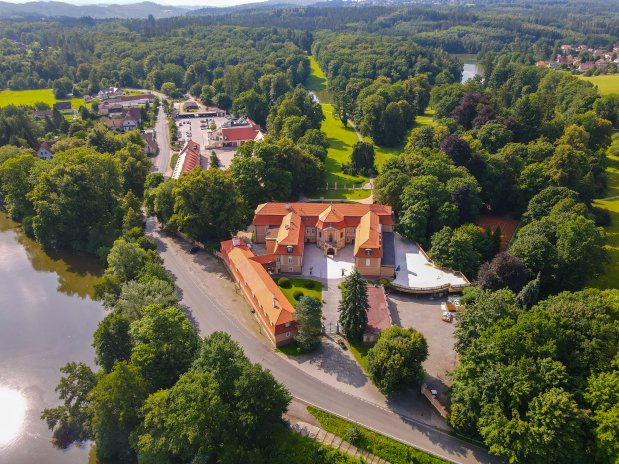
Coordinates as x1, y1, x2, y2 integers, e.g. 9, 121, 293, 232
221, 237, 297, 346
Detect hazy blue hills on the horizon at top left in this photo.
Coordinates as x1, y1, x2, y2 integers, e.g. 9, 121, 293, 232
0, 1, 189, 19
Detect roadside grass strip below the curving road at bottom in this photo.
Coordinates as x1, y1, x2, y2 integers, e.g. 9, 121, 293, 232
307, 406, 447, 464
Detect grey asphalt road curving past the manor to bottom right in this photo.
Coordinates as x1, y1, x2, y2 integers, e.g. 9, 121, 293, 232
148, 219, 500, 464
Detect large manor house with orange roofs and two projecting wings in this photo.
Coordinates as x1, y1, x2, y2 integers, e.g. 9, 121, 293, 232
251, 203, 395, 278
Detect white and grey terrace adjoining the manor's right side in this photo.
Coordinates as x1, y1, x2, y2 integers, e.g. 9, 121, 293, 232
394, 233, 466, 288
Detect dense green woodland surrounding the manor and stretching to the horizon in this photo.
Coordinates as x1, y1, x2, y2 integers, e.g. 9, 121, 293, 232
0, 2, 619, 464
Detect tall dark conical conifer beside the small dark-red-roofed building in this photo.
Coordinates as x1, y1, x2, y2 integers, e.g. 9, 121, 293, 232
338, 269, 370, 342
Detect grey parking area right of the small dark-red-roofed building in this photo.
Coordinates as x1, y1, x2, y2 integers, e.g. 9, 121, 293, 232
388, 293, 456, 400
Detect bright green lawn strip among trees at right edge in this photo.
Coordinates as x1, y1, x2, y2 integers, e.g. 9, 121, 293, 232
589, 132, 619, 289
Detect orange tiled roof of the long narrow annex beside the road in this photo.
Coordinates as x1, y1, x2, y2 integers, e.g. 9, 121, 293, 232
221, 240, 295, 326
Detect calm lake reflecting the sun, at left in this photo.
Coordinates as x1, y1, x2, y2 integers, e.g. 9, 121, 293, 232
0, 213, 105, 464
